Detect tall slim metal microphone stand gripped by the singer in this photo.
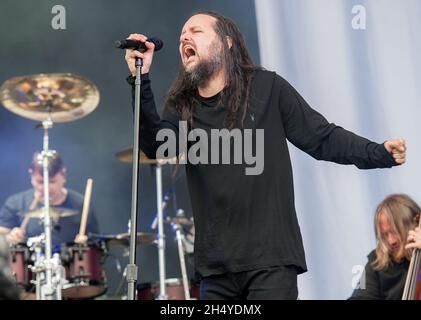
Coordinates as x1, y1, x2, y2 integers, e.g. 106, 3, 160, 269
126, 58, 143, 300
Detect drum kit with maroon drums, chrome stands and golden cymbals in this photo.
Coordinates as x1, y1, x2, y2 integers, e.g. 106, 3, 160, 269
0, 73, 198, 300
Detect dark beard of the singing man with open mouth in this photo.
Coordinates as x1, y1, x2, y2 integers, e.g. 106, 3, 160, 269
183, 40, 224, 88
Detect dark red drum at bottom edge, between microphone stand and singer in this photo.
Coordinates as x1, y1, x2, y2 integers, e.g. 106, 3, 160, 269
137, 279, 199, 300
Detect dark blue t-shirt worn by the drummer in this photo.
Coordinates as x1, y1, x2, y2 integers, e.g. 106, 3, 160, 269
0, 189, 98, 250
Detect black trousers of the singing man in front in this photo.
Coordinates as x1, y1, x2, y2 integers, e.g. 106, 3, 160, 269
200, 266, 298, 300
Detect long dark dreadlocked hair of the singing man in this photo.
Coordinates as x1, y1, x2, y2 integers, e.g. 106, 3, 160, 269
166, 11, 259, 129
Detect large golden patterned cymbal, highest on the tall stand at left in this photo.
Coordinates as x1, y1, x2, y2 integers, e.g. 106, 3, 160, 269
0, 73, 99, 122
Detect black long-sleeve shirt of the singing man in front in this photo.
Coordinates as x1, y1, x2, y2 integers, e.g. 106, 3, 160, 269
128, 70, 395, 276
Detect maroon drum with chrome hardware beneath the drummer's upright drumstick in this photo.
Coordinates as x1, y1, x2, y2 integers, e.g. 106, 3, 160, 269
62, 244, 107, 299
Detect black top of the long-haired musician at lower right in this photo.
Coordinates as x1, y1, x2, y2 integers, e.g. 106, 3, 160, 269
350, 250, 409, 300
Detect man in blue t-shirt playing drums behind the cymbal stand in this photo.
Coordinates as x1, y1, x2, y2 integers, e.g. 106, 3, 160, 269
0, 151, 98, 250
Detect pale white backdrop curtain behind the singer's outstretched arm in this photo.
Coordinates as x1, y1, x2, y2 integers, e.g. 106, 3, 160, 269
255, 0, 421, 299
